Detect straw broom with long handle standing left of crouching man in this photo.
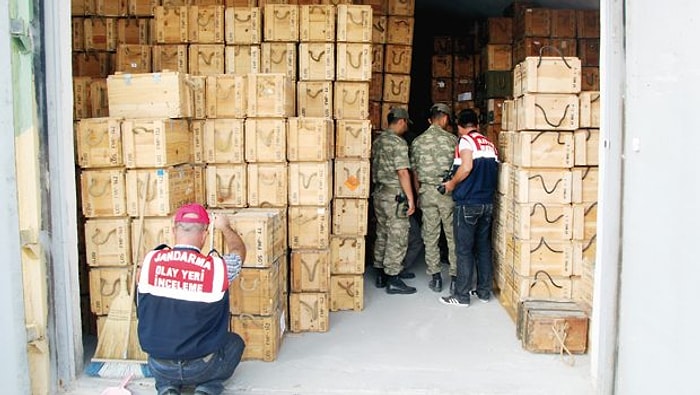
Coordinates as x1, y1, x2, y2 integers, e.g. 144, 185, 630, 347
85, 172, 151, 378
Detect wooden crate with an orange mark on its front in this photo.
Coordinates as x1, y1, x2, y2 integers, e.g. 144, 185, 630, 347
333, 158, 371, 199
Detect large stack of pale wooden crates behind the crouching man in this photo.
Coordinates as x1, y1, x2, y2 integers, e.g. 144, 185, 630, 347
72, 0, 394, 361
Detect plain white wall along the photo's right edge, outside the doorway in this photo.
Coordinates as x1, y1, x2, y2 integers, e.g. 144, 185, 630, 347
616, 0, 700, 394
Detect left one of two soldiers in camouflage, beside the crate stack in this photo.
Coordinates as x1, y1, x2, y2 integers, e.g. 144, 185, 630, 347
372, 108, 416, 294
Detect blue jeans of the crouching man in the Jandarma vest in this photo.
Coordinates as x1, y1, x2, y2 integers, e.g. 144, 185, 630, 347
148, 333, 245, 395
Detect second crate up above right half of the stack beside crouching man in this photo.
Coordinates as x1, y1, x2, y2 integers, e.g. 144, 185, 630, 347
244, 118, 287, 162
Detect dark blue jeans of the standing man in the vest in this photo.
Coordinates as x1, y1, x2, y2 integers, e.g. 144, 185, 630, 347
453, 204, 493, 302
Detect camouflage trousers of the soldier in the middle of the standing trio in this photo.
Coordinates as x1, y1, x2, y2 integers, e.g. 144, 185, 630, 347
419, 185, 457, 276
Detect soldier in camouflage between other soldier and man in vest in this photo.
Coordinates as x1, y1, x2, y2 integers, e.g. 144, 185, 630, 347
411, 103, 457, 292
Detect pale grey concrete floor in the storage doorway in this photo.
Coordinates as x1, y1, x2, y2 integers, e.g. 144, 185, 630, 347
66, 264, 594, 395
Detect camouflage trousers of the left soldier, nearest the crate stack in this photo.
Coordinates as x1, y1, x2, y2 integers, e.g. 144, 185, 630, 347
373, 193, 409, 276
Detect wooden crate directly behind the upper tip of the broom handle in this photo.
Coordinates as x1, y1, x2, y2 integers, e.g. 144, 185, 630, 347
126, 165, 194, 217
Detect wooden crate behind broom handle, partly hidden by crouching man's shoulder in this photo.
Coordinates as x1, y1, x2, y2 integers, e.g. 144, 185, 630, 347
129, 216, 175, 265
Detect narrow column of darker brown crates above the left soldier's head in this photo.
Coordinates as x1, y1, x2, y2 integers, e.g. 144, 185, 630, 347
358, 0, 415, 134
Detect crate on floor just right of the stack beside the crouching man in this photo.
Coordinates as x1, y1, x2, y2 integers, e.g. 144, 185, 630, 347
289, 292, 329, 333
